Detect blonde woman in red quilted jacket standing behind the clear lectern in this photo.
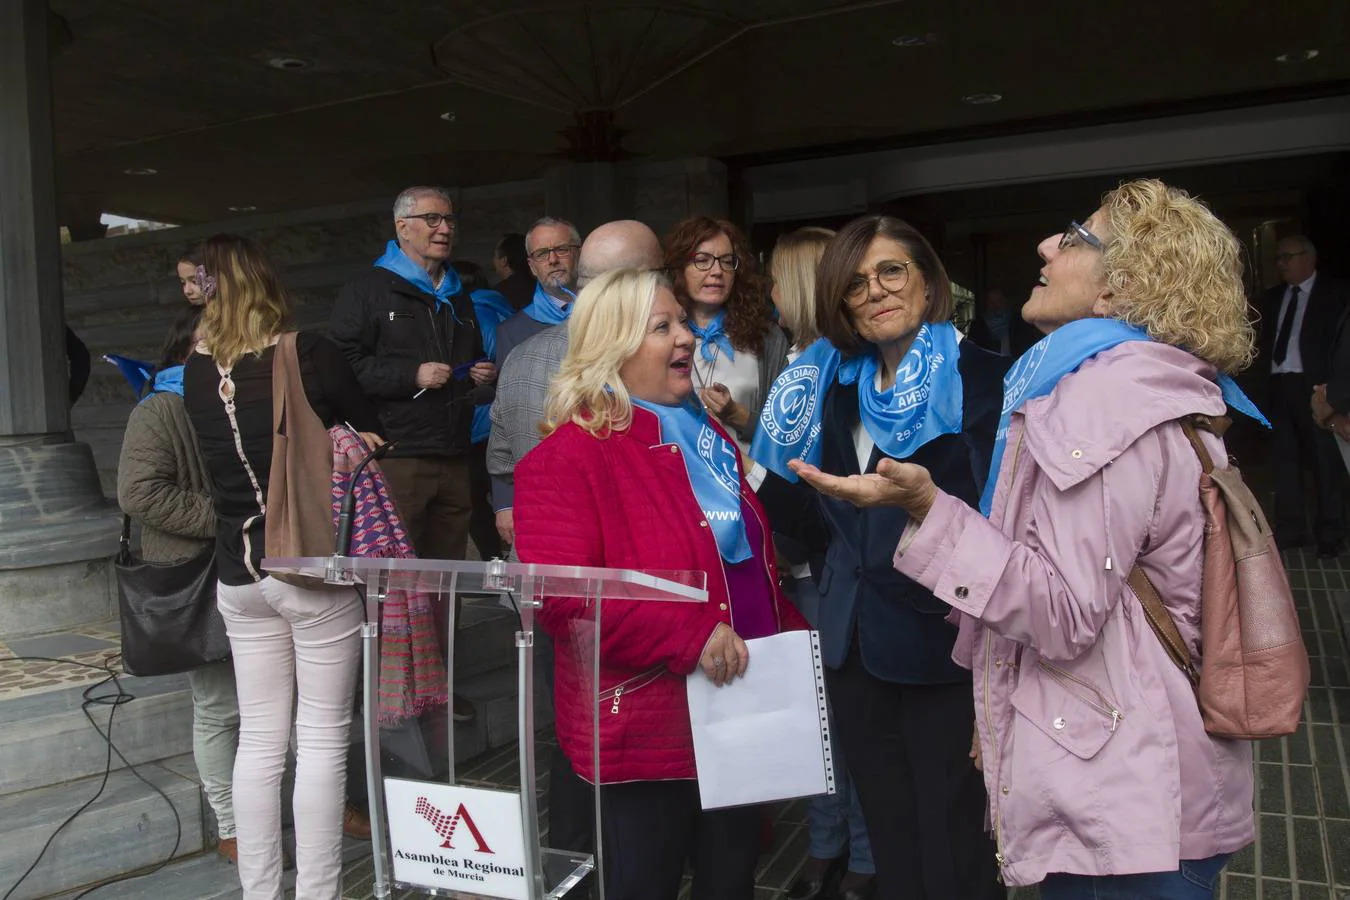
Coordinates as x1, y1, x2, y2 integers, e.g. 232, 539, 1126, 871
516, 270, 806, 900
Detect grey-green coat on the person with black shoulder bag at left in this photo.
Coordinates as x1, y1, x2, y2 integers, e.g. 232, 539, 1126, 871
117, 393, 216, 563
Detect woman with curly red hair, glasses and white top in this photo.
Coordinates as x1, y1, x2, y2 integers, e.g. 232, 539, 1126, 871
666, 216, 787, 449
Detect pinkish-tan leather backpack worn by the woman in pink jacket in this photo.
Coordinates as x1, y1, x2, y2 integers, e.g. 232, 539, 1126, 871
1129, 416, 1311, 741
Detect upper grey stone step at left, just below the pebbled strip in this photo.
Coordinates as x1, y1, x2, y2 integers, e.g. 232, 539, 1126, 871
0, 675, 192, 798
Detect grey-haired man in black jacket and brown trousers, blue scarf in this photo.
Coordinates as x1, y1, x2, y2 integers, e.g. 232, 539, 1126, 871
329, 188, 497, 722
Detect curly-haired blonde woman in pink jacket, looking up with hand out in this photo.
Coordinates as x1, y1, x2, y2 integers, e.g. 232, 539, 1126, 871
794, 181, 1260, 900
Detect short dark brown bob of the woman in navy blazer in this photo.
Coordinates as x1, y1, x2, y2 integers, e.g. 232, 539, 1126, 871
815, 215, 952, 355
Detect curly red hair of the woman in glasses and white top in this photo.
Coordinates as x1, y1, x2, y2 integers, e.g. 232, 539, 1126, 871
663, 216, 774, 354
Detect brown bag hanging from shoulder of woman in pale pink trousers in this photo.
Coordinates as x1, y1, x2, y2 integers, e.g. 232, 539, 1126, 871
266, 332, 336, 587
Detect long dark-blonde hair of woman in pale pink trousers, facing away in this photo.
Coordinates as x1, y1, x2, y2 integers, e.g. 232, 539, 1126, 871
198, 235, 290, 368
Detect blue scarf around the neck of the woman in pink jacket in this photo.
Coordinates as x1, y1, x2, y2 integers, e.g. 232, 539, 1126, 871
980, 318, 1270, 517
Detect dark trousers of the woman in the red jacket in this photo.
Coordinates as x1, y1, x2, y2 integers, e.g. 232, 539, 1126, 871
599, 781, 763, 900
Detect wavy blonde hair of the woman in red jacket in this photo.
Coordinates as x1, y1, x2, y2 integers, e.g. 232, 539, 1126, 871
540, 269, 670, 437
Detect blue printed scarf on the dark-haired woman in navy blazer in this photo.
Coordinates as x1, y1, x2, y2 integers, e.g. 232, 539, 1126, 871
751, 322, 964, 482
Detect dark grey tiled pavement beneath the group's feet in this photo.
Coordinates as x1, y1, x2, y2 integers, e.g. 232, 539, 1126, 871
324, 542, 1350, 900
